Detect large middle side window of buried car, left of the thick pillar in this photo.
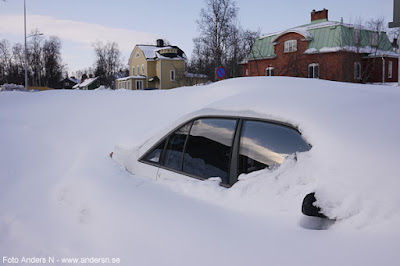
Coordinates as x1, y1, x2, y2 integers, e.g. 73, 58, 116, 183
183, 118, 237, 183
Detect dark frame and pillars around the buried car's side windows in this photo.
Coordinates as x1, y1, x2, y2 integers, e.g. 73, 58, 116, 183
138, 115, 312, 188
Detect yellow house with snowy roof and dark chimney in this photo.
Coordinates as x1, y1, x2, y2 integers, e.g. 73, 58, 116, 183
115, 39, 207, 90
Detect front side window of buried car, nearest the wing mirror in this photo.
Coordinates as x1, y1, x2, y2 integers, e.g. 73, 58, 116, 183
238, 120, 311, 174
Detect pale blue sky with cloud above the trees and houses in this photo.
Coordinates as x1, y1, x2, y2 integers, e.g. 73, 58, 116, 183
0, 0, 393, 73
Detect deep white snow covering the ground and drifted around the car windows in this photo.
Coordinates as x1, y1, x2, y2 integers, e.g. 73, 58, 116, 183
0, 77, 400, 266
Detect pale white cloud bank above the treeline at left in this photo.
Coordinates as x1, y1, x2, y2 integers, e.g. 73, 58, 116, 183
0, 15, 159, 70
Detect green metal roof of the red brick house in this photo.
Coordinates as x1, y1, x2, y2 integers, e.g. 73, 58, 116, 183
247, 19, 393, 60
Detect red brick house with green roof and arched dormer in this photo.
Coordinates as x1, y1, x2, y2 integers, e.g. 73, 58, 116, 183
241, 9, 398, 82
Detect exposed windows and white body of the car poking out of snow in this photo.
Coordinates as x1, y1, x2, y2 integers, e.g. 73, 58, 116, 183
112, 109, 311, 187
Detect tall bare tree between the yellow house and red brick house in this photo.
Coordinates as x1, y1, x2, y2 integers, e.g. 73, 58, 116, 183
189, 0, 259, 80
